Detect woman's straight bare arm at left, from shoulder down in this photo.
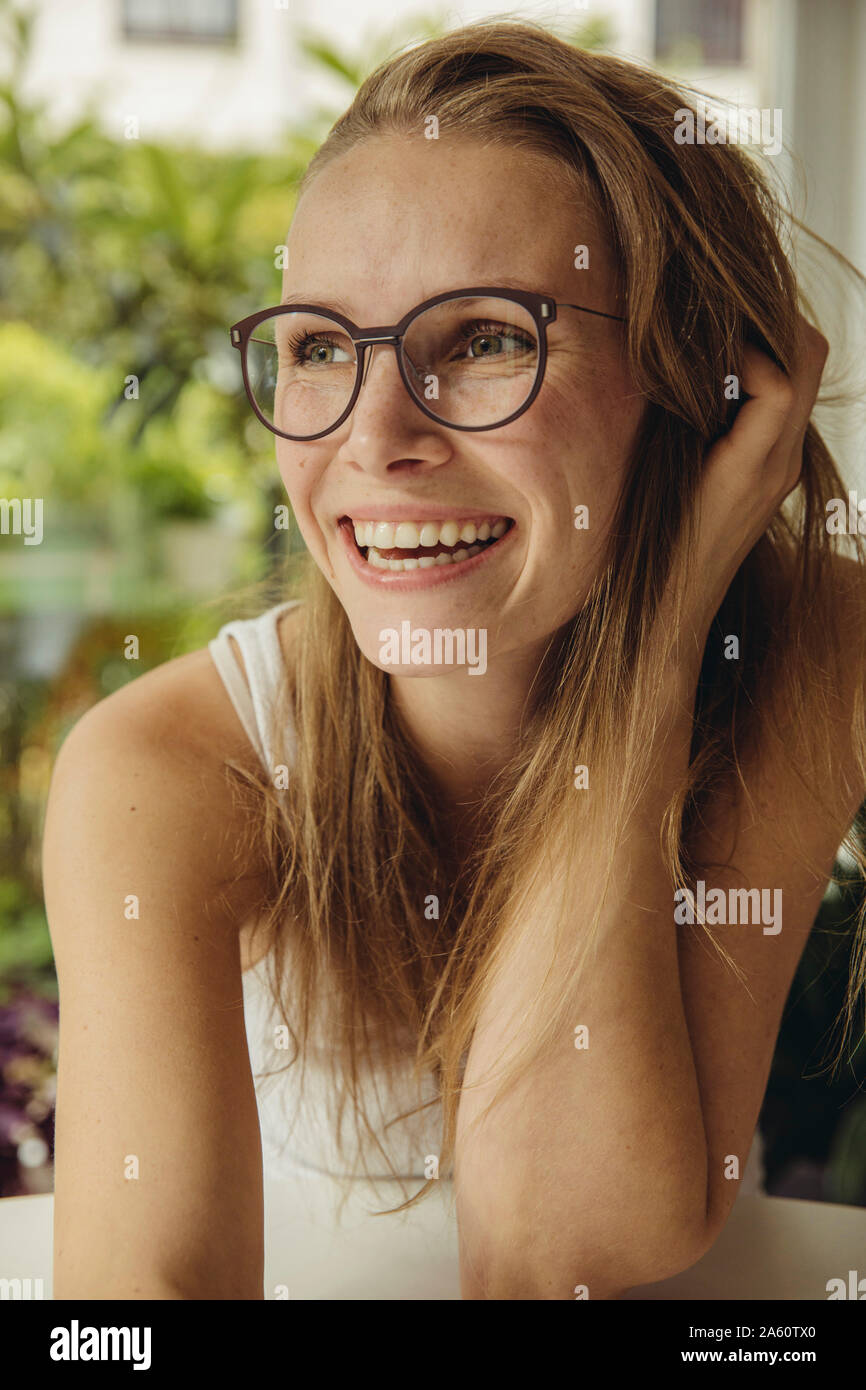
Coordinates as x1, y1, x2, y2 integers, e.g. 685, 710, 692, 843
43, 652, 263, 1298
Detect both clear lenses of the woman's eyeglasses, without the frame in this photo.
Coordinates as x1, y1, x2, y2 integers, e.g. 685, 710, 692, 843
246, 296, 539, 438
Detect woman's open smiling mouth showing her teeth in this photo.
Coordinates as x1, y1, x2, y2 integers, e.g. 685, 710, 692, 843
338, 516, 514, 573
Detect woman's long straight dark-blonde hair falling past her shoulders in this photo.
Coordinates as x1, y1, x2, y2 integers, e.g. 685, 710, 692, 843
222, 21, 866, 1209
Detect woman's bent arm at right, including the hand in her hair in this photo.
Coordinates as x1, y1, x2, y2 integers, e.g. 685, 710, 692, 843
456, 319, 863, 1298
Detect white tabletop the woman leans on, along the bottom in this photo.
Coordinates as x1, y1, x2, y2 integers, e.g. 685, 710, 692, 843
0, 1179, 866, 1301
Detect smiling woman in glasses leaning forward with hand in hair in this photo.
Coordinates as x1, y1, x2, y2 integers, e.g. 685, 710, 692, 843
44, 22, 866, 1298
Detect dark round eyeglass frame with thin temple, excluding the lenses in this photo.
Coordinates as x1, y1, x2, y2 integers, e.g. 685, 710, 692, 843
229, 285, 627, 443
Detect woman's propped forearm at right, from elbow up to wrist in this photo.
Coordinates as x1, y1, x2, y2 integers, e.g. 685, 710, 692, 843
456, 683, 708, 1298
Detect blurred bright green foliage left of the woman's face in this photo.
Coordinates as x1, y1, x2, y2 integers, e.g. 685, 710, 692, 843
0, 0, 306, 543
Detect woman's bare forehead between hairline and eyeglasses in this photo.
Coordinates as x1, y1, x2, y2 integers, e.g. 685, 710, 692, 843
284, 133, 613, 321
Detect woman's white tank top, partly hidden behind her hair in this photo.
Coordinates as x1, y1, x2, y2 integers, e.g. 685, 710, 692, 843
209, 599, 763, 1197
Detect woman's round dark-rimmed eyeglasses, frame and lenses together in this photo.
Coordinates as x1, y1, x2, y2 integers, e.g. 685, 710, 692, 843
231, 286, 626, 441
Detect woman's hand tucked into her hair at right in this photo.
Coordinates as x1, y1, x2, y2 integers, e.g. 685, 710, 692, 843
662, 314, 830, 680
